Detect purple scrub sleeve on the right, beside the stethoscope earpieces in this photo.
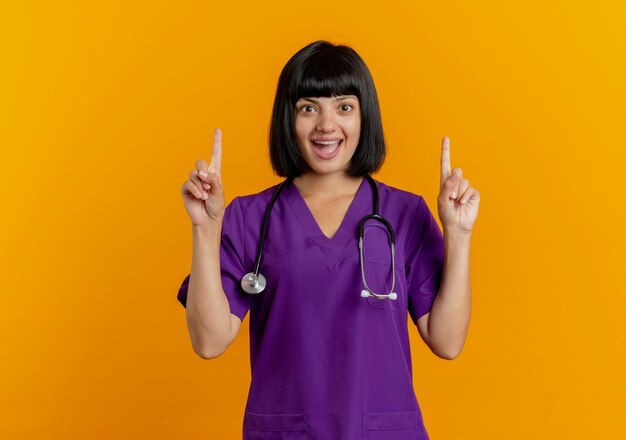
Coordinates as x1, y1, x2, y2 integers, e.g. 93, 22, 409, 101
404, 196, 444, 325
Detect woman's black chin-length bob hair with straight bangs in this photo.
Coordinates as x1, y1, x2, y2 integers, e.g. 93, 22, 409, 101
269, 40, 386, 177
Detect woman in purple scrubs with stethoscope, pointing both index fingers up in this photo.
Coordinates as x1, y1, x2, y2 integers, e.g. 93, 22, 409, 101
178, 41, 480, 440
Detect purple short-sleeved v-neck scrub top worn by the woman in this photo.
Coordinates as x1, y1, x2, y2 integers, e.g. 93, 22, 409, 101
178, 179, 444, 440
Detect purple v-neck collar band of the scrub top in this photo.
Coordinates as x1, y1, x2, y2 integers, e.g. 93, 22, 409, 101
284, 178, 373, 263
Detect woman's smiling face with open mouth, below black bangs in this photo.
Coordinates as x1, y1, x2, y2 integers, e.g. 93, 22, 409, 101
295, 95, 361, 174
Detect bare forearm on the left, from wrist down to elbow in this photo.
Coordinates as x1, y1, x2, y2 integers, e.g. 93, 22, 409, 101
186, 222, 231, 357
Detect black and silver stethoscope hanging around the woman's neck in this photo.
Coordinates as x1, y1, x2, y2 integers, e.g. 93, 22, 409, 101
241, 175, 398, 300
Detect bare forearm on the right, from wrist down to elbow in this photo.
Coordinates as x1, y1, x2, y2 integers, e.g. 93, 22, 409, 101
428, 230, 472, 359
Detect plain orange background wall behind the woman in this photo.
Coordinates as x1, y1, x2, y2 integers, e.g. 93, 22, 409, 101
0, 0, 626, 439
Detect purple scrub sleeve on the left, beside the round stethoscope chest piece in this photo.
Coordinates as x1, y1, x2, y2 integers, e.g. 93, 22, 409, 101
177, 197, 251, 321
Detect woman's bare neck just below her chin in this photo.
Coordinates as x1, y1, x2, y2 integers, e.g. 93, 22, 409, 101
293, 172, 364, 198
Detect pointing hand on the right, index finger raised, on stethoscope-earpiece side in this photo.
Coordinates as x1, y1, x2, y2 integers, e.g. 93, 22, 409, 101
437, 136, 480, 235
